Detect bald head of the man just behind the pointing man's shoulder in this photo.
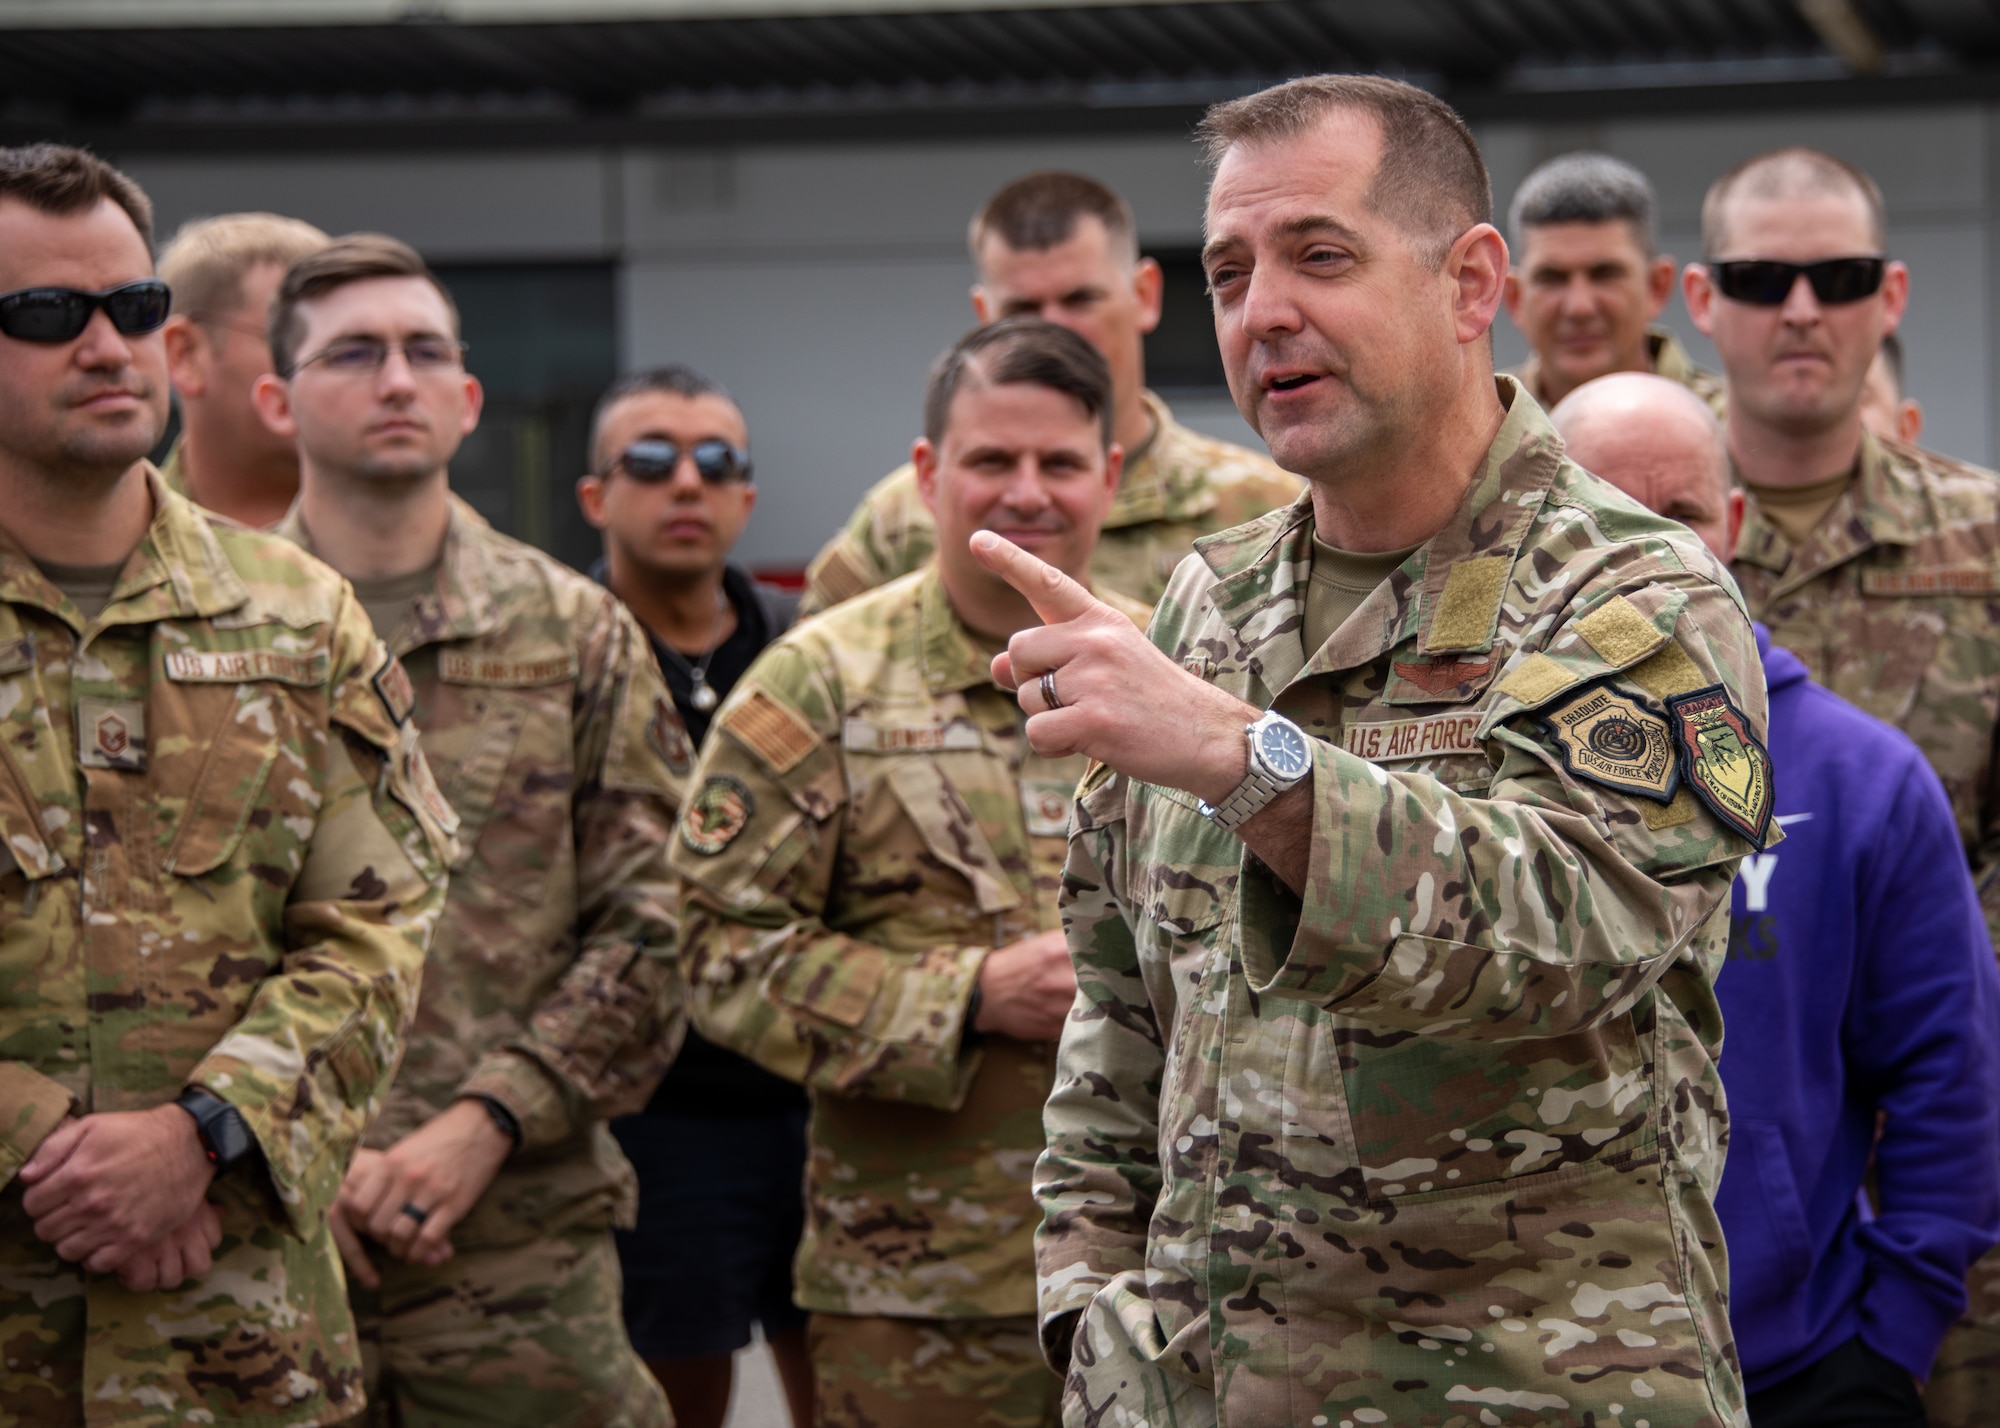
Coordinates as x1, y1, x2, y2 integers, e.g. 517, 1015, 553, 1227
1550, 372, 1736, 562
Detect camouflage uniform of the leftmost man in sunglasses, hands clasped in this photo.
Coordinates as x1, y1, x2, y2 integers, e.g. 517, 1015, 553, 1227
0, 472, 452, 1424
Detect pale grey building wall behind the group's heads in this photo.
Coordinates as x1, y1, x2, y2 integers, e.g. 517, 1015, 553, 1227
130, 106, 2000, 566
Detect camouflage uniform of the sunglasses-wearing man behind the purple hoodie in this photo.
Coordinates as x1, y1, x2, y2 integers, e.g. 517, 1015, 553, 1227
1732, 432, 2000, 1428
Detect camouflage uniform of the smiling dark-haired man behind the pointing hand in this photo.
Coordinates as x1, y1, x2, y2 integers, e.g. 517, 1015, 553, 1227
672, 568, 1144, 1424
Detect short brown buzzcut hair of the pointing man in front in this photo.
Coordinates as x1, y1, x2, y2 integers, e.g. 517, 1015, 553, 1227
1194, 74, 1494, 266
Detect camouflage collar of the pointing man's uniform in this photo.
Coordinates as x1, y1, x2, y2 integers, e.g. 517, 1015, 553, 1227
1194, 376, 1562, 692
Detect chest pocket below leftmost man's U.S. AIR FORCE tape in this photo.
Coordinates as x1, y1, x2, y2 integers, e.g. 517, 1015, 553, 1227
152, 684, 290, 878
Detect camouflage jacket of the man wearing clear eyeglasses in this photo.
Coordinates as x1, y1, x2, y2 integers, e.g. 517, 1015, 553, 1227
278, 496, 692, 1248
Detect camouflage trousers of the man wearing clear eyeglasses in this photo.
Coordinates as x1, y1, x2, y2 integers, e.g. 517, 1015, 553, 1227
350, 1226, 674, 1428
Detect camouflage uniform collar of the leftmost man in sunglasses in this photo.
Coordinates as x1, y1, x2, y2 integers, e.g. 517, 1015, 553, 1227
0, 462, 250, 630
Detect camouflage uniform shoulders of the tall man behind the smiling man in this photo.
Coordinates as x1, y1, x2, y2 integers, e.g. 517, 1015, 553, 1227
798, 392, 1304, 618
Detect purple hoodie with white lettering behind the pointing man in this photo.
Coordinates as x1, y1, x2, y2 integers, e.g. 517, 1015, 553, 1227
1716, 626, 2000, 1392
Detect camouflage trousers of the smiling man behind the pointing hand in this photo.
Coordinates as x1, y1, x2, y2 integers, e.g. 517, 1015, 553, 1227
806, 1314, 1062, 1428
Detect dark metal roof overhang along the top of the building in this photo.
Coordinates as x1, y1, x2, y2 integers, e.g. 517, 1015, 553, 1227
0, 0, 2000, 152
